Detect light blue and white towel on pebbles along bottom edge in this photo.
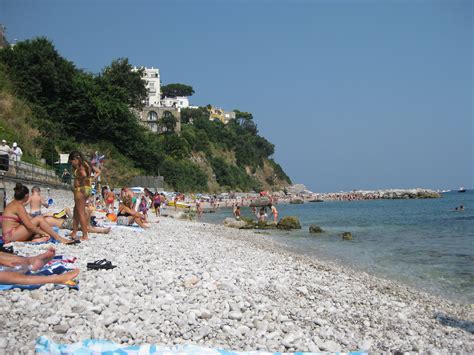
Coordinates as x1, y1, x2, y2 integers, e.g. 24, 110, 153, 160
35, 336, 367, 355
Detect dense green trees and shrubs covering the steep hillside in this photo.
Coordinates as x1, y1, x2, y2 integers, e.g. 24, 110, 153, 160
0, 38, 290, 191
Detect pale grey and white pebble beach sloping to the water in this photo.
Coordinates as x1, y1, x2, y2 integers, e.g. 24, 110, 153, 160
0, 185, 474, 354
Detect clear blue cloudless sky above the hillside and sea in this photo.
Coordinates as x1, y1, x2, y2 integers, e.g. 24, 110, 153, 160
0, 0, 474, 192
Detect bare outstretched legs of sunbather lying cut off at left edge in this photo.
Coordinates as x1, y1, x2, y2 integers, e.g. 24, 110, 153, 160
0, 248, 79, 285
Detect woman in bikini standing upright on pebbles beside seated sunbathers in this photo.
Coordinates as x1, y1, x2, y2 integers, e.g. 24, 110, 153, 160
69, 151, 92, 240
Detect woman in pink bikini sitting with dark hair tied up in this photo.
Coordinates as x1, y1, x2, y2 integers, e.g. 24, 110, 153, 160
2, 183, 74, 244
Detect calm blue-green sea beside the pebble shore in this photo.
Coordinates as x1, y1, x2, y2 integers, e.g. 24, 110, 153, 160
201, 190, 474, 304
